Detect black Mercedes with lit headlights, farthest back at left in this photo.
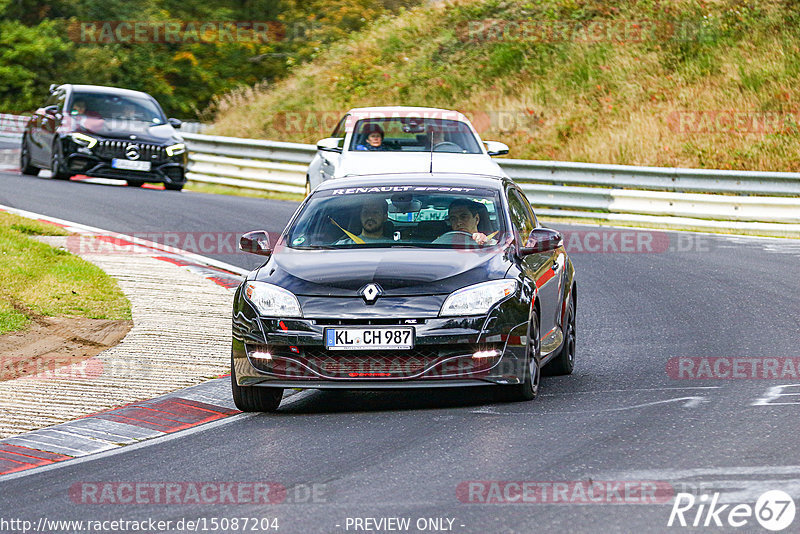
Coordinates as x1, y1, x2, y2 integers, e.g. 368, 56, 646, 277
20, 84, 186, 191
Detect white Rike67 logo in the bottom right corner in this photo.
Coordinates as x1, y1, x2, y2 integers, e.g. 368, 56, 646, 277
667, 490, 795, 532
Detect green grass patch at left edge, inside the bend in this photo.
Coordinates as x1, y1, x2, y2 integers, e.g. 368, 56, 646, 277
0, 213, 131, 334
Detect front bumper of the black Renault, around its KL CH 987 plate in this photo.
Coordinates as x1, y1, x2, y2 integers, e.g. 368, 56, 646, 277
232, 288, 528, 389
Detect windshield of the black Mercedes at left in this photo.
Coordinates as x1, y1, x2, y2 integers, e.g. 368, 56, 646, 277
69, 93, 166, 124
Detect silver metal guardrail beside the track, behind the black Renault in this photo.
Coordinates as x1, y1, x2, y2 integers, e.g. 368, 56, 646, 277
184, 134, 800, 236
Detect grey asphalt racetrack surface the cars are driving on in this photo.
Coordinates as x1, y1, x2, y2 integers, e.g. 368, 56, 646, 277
0, 173, 800, 533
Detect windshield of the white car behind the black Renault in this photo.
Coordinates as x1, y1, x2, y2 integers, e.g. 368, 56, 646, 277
350, 117, 482, 154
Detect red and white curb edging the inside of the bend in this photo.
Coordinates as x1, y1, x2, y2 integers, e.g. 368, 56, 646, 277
0, 205, 296, 480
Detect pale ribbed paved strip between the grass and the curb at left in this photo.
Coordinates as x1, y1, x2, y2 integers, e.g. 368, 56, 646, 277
0, 237, 238, 438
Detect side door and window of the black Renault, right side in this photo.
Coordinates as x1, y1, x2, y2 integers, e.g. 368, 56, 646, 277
507, 187, 562, 354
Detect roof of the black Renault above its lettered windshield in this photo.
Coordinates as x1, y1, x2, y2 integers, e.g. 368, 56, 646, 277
317, 172, 511, 191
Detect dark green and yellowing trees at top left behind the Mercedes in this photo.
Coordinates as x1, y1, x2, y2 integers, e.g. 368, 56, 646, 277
0, 0, 419, 118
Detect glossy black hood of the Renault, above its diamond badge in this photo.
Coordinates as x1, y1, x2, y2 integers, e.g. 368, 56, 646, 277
256, 247, 509, 297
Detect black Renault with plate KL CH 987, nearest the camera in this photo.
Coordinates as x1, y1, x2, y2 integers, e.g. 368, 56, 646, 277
231, 174, 577, 411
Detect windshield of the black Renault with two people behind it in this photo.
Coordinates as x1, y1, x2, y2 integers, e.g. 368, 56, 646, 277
285, 185, 505, 249
